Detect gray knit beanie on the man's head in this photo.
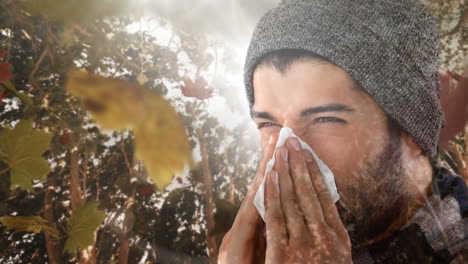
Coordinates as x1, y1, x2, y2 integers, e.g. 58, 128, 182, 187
244, 0, 443, 160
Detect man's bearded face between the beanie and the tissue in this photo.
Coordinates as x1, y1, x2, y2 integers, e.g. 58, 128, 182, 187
252, 60, 406, 243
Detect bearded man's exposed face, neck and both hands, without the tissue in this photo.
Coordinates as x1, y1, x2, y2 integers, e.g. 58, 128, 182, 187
219, 59, 432, 263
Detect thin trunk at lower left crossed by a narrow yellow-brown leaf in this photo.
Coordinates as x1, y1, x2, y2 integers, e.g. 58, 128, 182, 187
44, 168, 64, 264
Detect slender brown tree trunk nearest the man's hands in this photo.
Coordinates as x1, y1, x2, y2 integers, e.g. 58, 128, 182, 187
198, 130, 218, 264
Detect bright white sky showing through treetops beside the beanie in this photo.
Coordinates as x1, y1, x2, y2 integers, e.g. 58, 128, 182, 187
122, 0, 279, 189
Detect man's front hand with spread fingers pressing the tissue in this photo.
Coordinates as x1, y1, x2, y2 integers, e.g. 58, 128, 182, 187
265, 138, 352, 264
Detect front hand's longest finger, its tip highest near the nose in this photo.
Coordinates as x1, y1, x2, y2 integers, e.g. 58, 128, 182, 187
287, 138, 325, 227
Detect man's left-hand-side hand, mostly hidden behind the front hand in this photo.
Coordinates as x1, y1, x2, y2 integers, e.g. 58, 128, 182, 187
218, 137, 277, 264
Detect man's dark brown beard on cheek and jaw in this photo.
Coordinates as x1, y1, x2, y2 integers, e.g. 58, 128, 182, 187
336, 125, 409, 247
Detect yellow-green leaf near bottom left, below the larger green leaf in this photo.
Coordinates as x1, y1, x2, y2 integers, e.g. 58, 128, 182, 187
64, 201, 106, 254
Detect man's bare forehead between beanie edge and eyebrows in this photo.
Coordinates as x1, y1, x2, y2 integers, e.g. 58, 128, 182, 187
253, 60, 366, 111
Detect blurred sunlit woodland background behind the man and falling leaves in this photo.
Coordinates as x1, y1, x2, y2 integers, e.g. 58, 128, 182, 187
0, 0, 468, 263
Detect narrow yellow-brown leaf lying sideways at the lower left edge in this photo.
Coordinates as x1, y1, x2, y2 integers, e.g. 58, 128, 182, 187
0, 216, 59, 237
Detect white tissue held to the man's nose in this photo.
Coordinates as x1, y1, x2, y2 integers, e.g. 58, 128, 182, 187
254, 127, 340, 221
